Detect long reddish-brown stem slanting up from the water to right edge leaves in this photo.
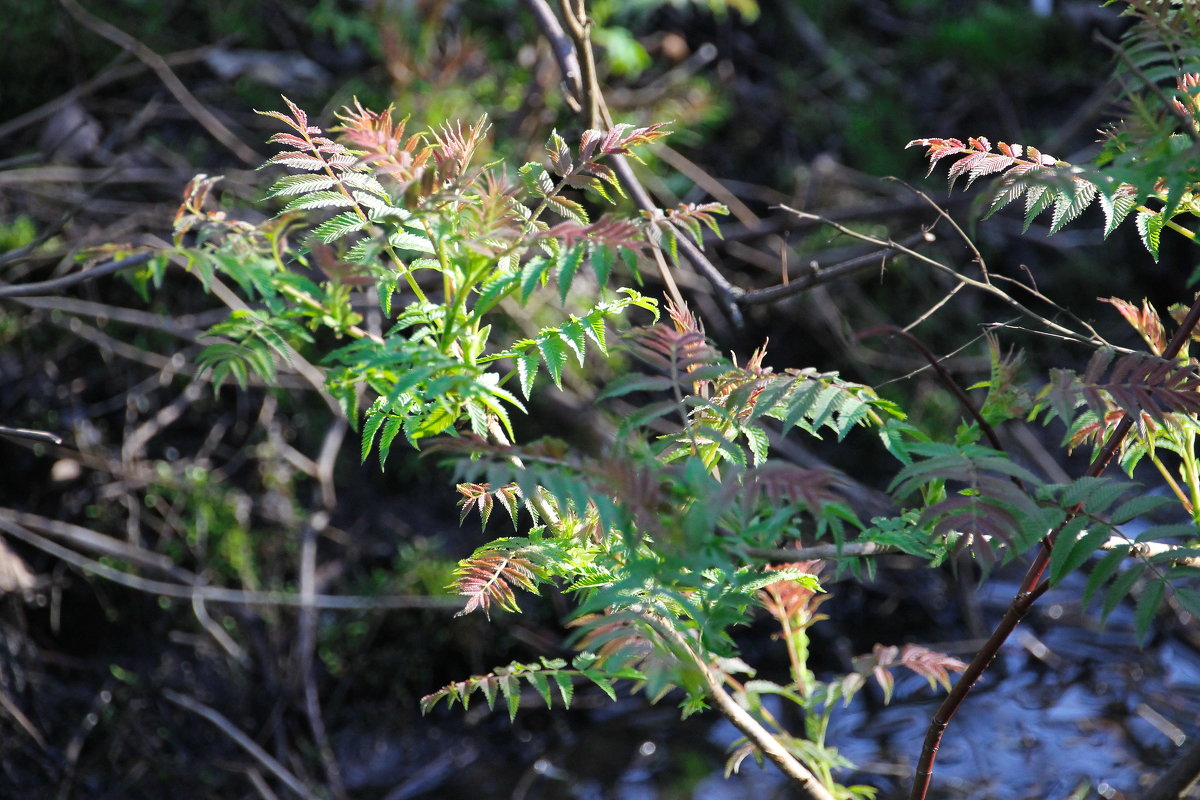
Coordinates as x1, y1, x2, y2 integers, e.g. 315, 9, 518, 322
908, 296, 1200, 800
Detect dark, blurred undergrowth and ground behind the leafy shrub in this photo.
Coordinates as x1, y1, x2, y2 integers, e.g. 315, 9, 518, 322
0, 0, 1194, 800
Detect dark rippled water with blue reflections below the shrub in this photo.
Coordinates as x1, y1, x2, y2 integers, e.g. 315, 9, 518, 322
384, 568, 1200, 800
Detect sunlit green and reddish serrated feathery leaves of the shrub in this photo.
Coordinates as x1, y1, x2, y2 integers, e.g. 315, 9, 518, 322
162, 20, 1200, 800
